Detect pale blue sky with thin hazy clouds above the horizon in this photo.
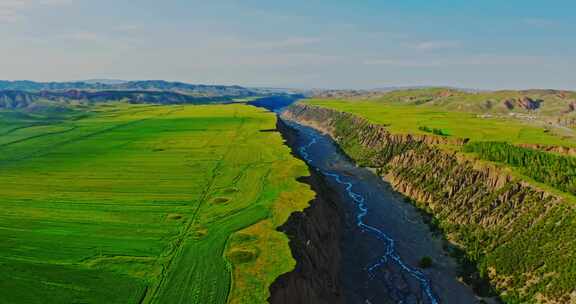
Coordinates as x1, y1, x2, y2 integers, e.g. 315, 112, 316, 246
0, 0, 576, 89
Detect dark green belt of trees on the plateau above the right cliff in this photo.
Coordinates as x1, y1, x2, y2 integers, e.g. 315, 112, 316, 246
464, 142, 576, 195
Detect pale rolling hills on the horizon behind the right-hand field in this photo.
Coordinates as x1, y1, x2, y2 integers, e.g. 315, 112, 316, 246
316, 88, 576, 127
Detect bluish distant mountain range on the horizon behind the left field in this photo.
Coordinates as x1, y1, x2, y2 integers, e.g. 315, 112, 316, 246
0, 79, 272, 111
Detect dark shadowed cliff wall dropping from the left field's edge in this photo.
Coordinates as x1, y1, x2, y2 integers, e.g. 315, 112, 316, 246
269, 121, 344, 304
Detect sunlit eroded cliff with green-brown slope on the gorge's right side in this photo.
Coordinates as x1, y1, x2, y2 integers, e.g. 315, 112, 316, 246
283, 104, 576, 303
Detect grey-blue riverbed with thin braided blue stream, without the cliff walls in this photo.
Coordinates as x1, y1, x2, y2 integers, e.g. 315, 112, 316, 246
286, 117, 477, 304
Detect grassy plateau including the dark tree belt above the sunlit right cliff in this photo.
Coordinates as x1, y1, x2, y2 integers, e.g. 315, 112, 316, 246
306, 93, 576, 195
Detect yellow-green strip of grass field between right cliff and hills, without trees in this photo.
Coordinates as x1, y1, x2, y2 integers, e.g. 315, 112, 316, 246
306, 99, 576, 147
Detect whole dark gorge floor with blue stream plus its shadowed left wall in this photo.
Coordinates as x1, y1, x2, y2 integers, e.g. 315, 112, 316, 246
260, 97, 478, 304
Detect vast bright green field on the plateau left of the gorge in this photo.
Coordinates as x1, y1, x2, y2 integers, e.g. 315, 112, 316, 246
0, 103, 313, 303
